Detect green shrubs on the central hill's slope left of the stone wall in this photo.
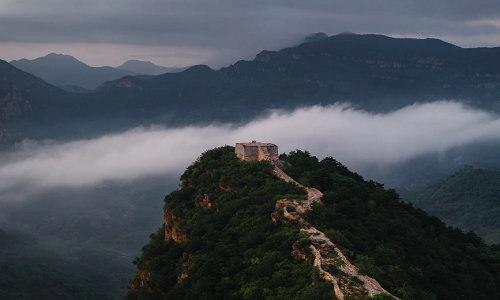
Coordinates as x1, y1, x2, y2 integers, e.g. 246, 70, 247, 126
126, 147, 334, 300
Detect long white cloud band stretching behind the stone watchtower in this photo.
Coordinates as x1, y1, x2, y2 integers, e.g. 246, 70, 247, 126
0, 101, 500, 201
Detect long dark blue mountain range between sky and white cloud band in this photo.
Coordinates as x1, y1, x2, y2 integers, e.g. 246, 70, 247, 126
0, 34, 500, 148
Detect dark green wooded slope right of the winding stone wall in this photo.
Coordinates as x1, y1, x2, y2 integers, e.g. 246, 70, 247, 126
280, 151, 500, 300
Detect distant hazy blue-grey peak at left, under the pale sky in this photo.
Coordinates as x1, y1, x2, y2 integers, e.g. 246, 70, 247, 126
10, 53, 135, 90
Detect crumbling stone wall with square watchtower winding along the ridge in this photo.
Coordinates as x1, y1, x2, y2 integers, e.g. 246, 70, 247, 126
235, 141, 400, 300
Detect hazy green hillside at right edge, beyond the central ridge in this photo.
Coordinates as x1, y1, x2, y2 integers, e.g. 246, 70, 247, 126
407, 166, 500, 243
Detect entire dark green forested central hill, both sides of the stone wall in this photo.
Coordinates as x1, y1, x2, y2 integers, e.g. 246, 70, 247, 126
127, 146, 500, 300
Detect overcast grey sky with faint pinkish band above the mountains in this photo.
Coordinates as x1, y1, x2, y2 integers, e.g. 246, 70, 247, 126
0, 0, 500, 68
